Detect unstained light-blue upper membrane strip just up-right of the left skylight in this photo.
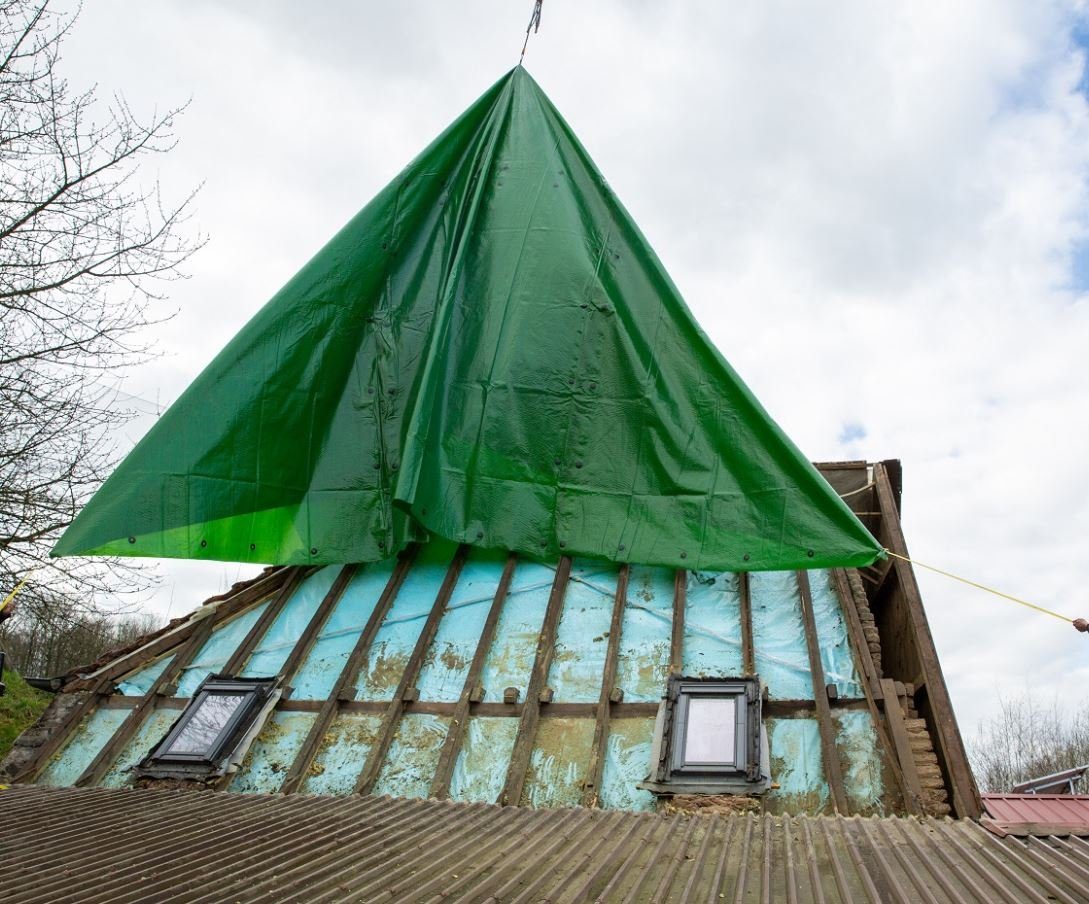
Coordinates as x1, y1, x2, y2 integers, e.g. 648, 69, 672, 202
292, 559, 396, 700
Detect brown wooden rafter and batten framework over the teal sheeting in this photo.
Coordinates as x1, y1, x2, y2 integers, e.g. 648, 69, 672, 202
0, 463, 978, 816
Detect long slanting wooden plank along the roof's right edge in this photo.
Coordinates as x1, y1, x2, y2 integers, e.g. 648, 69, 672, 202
873, 463, 982, 819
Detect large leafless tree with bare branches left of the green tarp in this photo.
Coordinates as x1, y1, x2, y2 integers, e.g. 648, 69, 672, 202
0, 0, 201, 644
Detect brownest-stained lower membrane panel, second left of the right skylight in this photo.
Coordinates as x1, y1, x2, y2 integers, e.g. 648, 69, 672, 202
520, 717, 595, 807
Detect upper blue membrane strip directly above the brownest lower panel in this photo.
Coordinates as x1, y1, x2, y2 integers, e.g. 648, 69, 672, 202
547, 560, 619, 704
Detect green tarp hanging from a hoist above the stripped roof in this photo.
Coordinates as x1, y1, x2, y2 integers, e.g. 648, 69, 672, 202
54, 68, 880, 571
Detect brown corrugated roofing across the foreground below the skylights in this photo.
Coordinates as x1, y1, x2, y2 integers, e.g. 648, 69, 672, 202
0, 786, 1089, 904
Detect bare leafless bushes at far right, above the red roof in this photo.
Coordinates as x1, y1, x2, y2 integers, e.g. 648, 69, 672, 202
970, 692, 1089, 792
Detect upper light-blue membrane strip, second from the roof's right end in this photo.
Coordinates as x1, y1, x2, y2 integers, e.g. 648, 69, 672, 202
753, 572, 813, 700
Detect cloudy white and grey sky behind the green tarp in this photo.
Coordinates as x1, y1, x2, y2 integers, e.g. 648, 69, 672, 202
53, 0, 1089, 737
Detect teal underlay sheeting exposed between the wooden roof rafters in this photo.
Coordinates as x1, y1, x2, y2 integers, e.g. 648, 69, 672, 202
74, 553, 886, 811
